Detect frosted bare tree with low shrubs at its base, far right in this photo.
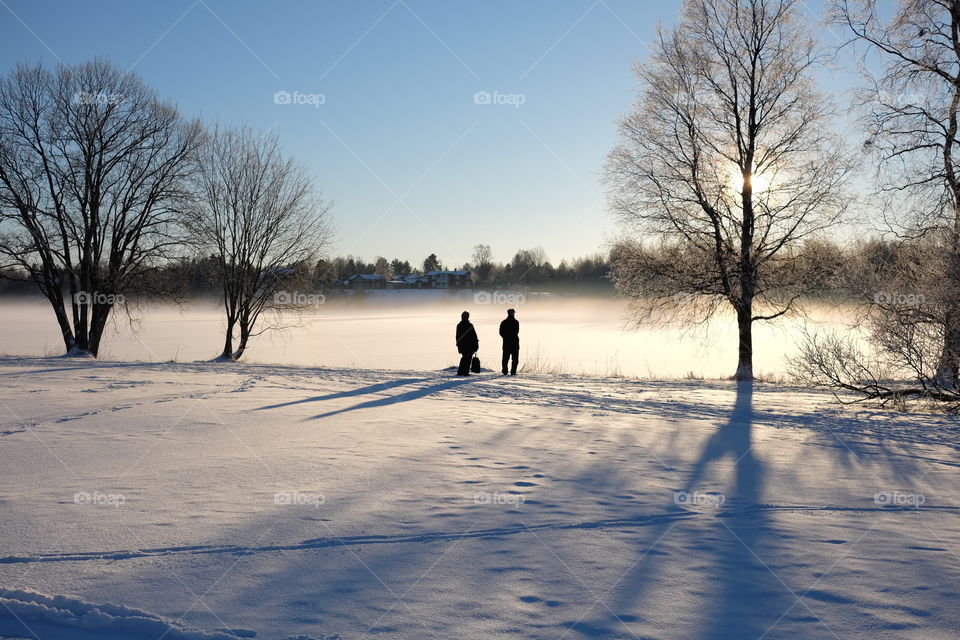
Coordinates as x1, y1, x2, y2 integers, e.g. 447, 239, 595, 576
800, 0, 960, 401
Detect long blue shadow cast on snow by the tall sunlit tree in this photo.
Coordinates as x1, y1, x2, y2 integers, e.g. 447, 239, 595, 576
573, 382, 812, 640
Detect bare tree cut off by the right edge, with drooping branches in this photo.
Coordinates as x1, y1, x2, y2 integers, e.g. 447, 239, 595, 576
832, 0, 960, 390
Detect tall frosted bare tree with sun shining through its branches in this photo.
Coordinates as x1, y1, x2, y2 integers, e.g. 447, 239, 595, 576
606, 0, 849, 379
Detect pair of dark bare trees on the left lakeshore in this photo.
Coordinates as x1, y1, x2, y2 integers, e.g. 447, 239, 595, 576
0, 60, 329, 358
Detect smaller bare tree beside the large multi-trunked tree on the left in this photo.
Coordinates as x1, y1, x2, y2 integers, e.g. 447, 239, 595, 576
186, 128, 332, 360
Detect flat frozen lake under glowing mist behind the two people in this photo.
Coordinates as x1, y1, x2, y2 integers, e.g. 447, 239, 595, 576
0, 291, 856, 378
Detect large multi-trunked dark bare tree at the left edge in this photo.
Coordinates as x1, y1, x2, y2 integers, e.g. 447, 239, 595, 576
0, 60, 200, 356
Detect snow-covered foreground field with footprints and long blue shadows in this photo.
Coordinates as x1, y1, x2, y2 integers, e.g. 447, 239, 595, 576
0, 358, 960, 640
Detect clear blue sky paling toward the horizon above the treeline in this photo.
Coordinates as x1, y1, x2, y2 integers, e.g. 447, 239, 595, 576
0, 0, 852, 266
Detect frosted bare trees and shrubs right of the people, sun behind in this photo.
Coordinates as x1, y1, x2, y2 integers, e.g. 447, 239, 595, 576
606, 0, 960, 398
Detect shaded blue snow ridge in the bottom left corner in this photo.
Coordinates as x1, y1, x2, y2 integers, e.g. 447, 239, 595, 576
0, 589, 251, 640
